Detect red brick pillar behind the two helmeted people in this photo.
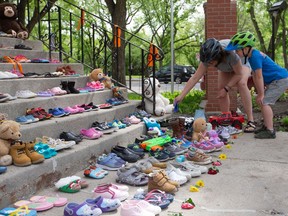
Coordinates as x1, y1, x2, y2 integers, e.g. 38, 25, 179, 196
204, 0, 237, 112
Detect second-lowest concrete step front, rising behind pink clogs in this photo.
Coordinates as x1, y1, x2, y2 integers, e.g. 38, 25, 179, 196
21, 101, 140, 141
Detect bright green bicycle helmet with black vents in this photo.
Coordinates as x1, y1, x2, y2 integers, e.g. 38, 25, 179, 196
225, 32, 256, 51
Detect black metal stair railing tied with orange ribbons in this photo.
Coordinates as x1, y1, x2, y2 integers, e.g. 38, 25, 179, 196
18, 0, 164, 113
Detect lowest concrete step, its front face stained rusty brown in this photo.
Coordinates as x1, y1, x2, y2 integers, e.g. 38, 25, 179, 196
0, 119, 146, 209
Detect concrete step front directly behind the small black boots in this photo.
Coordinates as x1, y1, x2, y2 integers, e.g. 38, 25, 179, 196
0, 76, 89, 96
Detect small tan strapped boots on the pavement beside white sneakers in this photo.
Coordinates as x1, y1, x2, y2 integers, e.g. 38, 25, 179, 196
148, 170, 178, 193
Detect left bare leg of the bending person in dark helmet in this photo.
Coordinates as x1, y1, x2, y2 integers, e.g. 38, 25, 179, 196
218, 71, 232, 112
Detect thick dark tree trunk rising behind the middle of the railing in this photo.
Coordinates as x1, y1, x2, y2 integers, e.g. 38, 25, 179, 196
105, 0, 127, 85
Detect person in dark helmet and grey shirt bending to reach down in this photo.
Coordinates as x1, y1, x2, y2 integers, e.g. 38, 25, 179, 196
174, 38, 256, 132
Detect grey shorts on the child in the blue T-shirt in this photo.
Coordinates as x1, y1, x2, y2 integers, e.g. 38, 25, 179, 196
263, 78, 288, 105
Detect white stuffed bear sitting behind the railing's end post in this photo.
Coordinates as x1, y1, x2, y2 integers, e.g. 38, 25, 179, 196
144, 78, 174, 116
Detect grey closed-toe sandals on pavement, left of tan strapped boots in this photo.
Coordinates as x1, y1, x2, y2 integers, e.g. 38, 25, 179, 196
116, 166, 148, 186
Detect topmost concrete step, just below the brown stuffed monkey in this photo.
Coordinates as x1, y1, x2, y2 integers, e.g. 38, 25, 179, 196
0, 37, 43, 51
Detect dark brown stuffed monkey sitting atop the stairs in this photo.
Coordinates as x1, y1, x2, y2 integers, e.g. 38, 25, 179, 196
0, 2, 29, 40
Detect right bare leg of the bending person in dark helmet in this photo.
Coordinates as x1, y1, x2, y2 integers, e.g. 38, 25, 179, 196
237, 66, 254, 122
